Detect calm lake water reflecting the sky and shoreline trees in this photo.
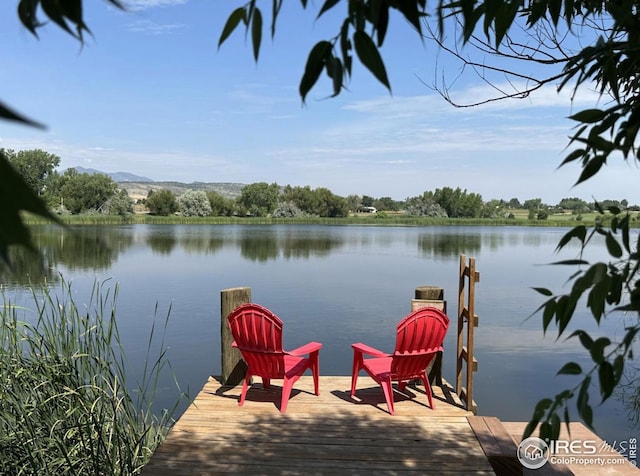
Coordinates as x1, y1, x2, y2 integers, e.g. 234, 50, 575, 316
2, 225, 640, 442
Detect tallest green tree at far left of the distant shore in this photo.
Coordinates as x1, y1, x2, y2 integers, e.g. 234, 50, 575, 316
3, 149, 60, 197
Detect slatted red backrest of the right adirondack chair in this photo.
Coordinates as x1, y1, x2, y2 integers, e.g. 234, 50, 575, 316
391, 307, 449, 378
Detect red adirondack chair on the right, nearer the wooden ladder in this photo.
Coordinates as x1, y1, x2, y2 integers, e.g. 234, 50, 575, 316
351, 307, 449, 415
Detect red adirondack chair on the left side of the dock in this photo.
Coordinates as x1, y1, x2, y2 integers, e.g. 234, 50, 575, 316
227, 303, 322, 413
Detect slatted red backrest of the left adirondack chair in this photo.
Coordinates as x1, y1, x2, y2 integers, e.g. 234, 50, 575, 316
227, 303, 285, 378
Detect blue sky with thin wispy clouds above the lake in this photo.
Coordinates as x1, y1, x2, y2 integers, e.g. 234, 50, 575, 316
0, 0, 640, 204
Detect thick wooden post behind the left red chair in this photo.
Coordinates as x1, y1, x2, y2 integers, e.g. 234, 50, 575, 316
220, 288, 251, 386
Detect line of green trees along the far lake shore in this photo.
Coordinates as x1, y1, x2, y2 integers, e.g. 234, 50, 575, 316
2, 149, 640, 220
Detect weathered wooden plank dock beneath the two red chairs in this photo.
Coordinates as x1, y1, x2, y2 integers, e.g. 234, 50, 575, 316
142, 375, 638, 476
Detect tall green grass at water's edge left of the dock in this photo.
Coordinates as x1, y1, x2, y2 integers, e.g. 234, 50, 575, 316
0, 282, 182, 475
